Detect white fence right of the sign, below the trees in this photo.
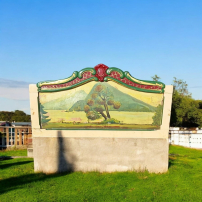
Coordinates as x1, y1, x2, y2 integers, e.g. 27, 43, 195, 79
169, 127, 202, 149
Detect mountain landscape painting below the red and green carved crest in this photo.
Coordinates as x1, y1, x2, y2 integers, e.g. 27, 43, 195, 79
39, 81, 163, 130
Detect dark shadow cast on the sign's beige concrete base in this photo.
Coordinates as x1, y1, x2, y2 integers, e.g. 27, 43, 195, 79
57, 131, 76, 173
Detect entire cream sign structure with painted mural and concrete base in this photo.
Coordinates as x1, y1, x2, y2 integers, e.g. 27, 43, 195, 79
30, 64, 173, 173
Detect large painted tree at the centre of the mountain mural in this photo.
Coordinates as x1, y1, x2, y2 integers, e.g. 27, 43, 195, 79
84, 85, 121, 120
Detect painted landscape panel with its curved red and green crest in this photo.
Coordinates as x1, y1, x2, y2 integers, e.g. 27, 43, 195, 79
37, 64, 165, 130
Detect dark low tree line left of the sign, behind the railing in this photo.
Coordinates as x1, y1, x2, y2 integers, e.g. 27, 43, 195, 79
0, 110, 31, 122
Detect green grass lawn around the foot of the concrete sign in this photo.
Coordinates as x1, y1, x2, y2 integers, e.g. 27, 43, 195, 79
0, 146, 202, 202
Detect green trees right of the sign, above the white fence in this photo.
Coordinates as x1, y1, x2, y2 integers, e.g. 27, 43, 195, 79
152, 75, 202, 127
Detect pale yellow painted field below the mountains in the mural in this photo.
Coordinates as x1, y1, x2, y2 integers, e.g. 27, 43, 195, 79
46, 110, 154, 124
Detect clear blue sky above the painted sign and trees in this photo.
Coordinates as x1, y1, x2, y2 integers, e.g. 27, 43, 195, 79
0, 0, 202, 113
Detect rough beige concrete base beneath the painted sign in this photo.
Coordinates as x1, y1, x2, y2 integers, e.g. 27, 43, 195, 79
33, 137, 168, 173
